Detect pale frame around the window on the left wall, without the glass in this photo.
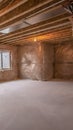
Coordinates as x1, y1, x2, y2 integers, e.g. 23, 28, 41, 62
0, 50, 12, 71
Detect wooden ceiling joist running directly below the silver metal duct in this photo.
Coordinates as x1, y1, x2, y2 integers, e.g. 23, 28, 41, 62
0, 14, 68, 39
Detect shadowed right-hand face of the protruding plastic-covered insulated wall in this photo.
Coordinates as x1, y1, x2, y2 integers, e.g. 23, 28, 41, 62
42, 43, 54, 80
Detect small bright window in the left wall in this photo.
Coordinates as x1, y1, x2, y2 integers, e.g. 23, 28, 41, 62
0, 51, 11, 70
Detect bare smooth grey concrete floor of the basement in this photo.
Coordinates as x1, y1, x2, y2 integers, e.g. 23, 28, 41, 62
0, 80, 73, 130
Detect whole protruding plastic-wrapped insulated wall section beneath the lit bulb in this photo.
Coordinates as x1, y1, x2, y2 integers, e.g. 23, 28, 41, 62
19, 43, 53, 80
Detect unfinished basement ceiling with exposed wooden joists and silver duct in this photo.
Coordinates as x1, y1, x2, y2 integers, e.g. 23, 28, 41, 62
0, 0, 73, 45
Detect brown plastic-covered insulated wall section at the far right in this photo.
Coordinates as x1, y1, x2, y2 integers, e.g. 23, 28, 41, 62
55, 42, 73, 79
